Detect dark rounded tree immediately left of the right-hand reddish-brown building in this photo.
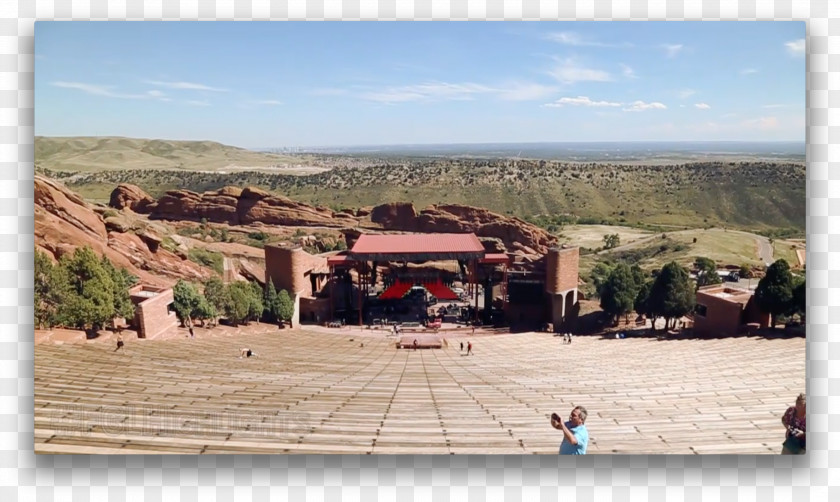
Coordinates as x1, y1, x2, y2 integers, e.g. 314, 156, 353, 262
646, 261, 695, 330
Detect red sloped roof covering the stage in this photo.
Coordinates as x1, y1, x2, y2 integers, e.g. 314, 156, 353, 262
347, 234, 485, 261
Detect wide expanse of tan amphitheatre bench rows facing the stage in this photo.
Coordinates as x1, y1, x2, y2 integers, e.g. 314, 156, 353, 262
34, 329, 806, 454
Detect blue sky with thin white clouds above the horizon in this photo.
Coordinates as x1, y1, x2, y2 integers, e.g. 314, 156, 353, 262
35, 21, 806, 148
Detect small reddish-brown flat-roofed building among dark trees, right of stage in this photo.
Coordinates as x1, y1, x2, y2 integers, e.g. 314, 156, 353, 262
694, 284, 770, 336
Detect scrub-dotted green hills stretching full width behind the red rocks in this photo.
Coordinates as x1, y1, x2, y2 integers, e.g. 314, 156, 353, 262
36, 138, 806, 235
